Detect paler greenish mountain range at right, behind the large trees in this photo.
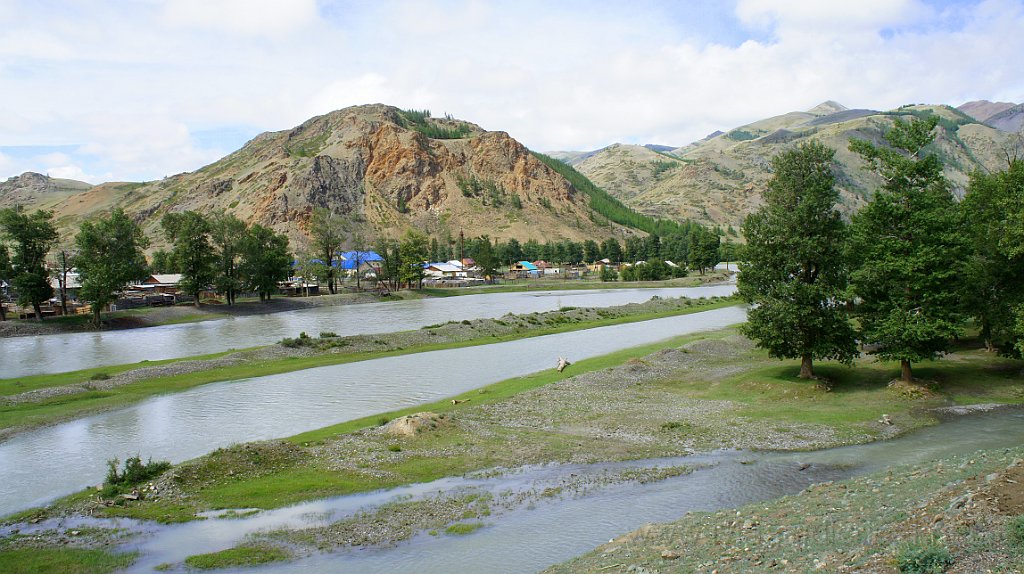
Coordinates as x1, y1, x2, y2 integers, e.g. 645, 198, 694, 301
563, 101, 1018, 225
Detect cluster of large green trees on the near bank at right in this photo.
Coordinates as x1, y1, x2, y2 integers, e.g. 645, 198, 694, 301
739, 117, 1024, 382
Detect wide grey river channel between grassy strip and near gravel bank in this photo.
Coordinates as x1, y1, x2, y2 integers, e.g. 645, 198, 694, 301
0, 304, 746, 516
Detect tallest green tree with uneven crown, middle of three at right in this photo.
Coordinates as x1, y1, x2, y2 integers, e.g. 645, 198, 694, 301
850, 116, 967, 383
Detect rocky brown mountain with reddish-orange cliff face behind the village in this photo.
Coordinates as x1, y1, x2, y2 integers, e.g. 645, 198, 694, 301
9, 104, 632, 251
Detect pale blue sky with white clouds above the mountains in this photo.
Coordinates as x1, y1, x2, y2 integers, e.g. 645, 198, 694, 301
0, 0, 1024, 183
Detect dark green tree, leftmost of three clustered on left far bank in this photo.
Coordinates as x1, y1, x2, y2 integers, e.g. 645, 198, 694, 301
160, 211, 216, 307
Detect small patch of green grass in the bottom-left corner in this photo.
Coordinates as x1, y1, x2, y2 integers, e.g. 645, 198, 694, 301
0, 548, 138, 574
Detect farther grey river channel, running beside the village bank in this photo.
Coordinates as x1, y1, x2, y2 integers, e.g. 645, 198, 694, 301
0, 283, 736, 379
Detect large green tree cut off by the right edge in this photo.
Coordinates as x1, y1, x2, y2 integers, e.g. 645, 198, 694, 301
961, 159, 1024, 356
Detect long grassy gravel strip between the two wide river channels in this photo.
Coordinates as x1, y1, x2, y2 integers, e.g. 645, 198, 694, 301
0, 299, 736, 435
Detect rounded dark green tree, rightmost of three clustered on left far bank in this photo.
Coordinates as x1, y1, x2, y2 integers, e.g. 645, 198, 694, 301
239, 224, 292, 302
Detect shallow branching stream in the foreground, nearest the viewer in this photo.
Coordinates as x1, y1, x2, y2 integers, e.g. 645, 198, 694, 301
9, 409, 1024, 574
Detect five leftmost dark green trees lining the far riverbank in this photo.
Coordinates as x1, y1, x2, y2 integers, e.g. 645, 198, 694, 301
0, 208, 292, 324
